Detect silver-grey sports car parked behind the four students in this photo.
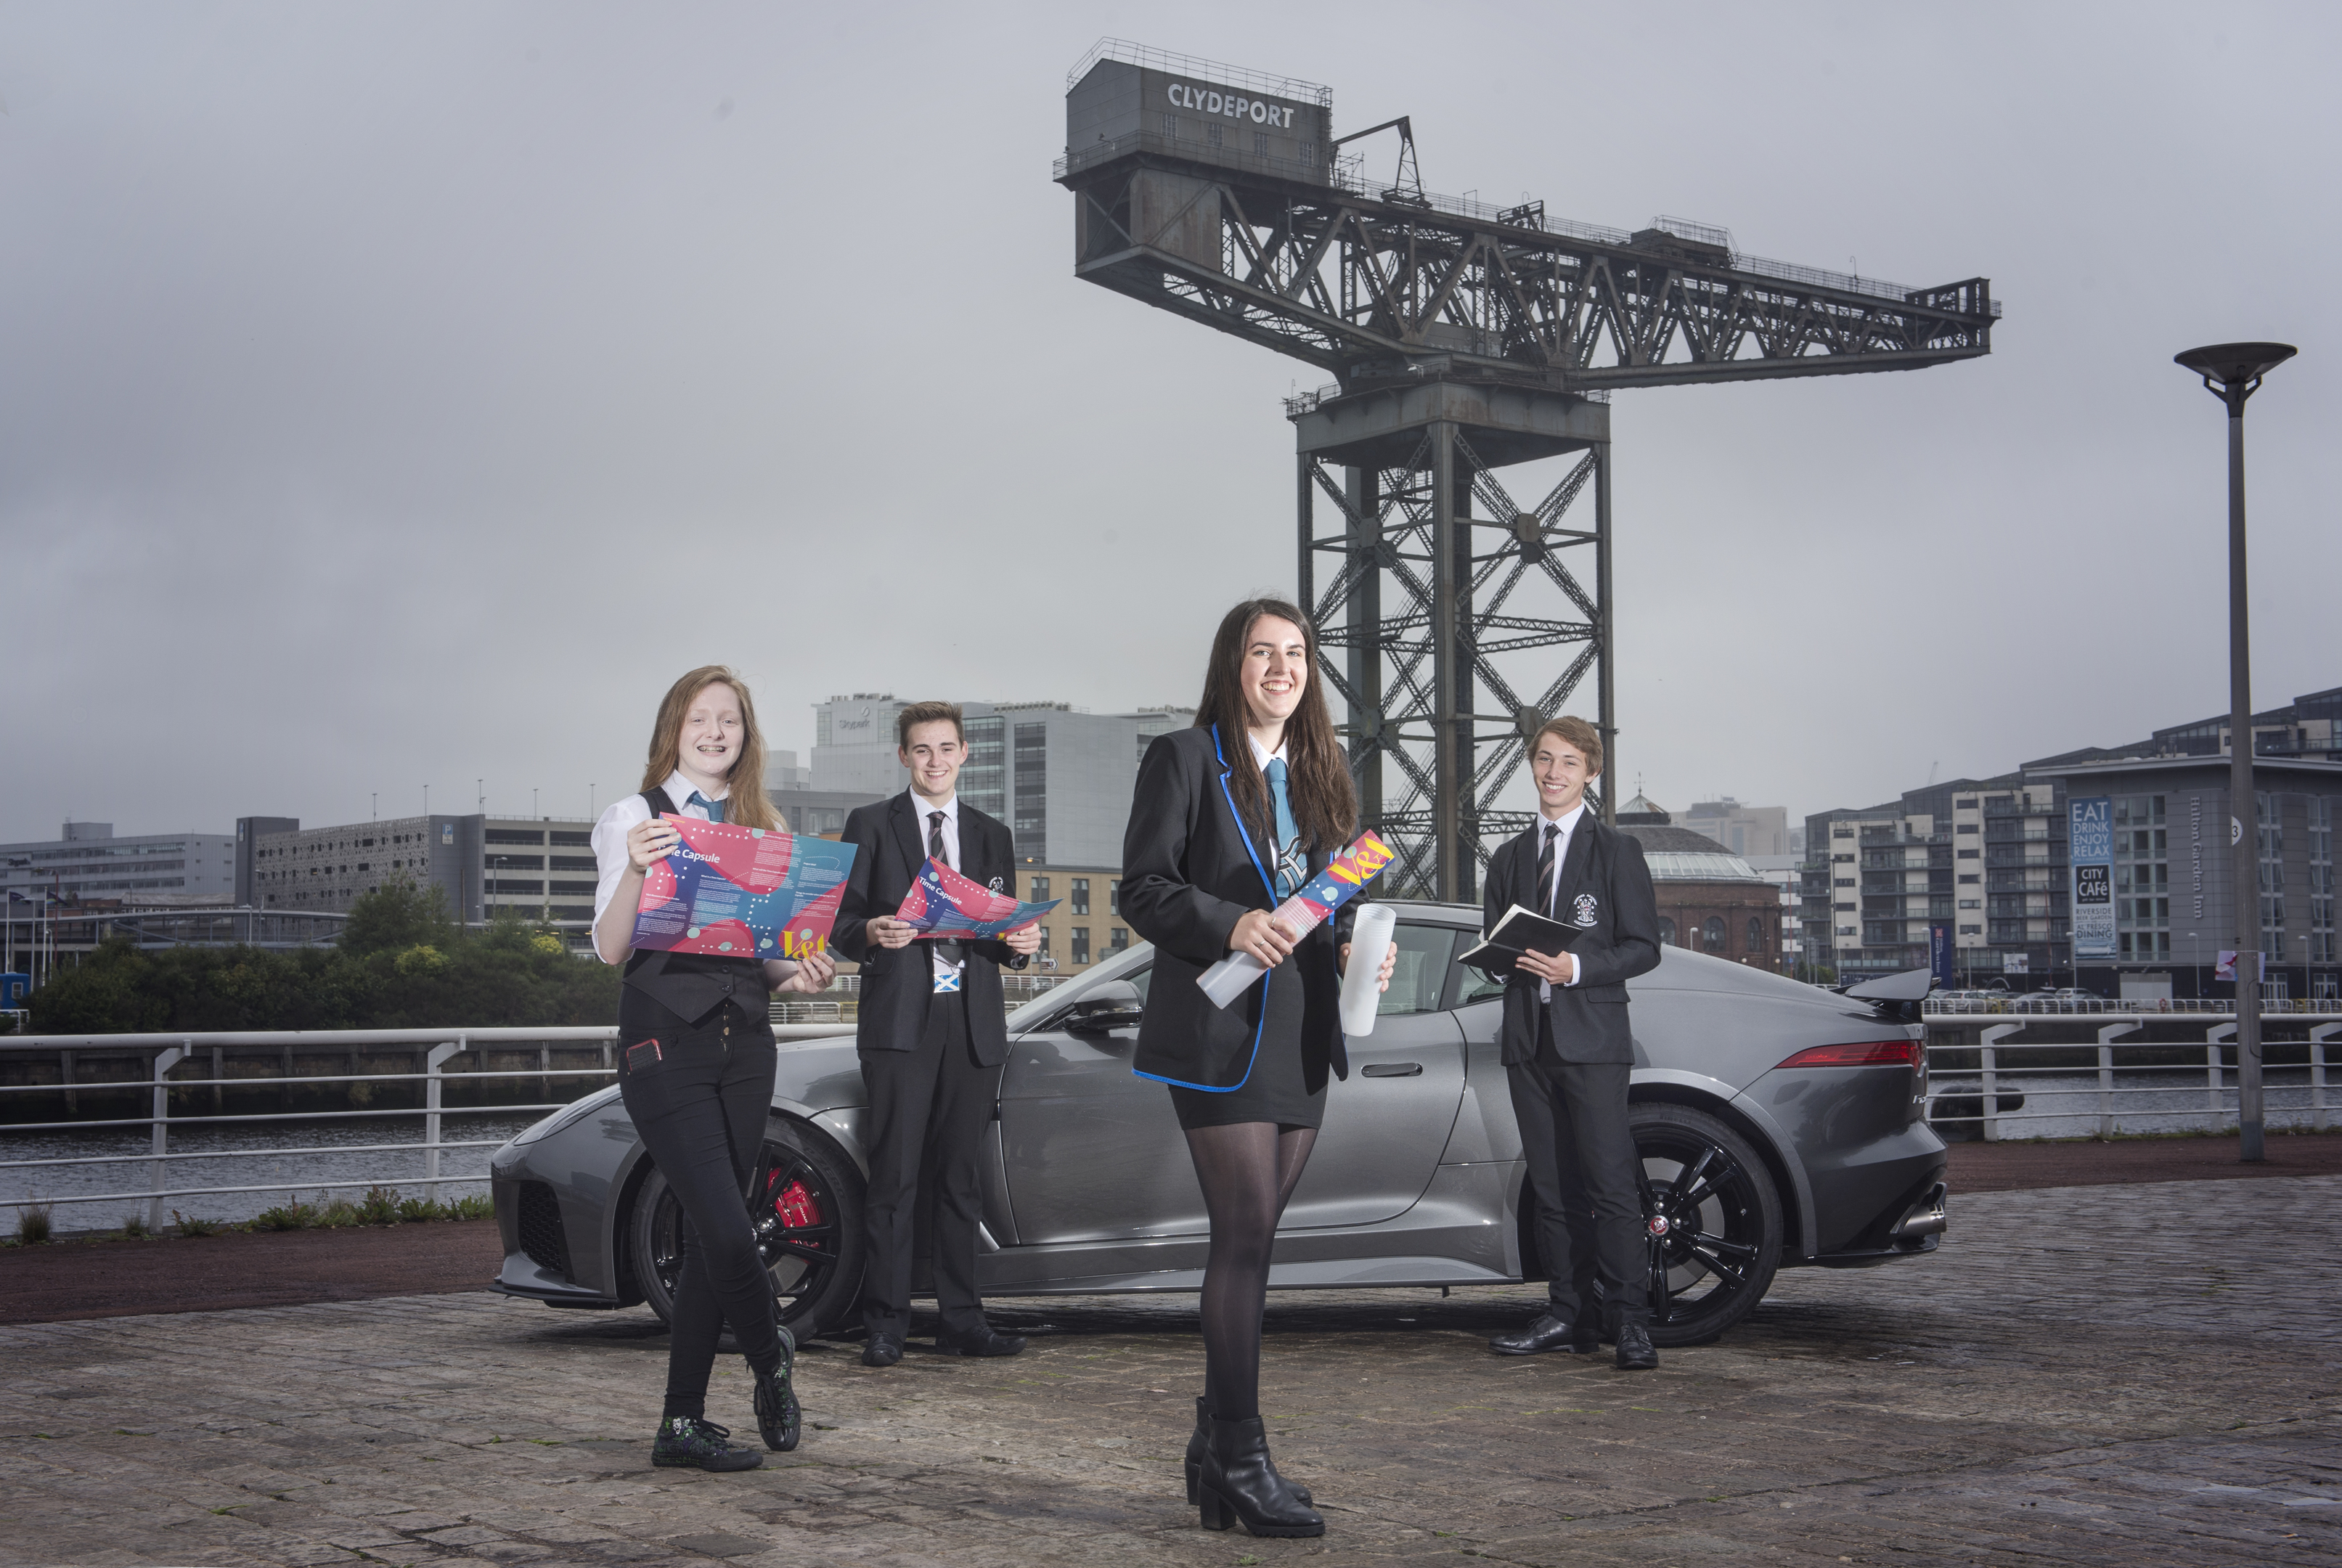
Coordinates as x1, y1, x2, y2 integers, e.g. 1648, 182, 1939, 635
491, 903, 1944, 1346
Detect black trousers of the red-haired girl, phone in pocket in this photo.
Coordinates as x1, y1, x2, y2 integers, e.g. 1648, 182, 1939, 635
619, 985, 780, 1416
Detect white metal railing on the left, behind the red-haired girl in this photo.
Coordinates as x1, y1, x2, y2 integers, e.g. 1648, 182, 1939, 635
0, 1025, 836, 1231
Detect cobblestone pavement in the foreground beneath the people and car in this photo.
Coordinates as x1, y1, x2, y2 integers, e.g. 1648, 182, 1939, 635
0, 1177, 2342, 1568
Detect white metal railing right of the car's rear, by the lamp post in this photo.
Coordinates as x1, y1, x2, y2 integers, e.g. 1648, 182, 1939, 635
1927, 1018, 2342, 1142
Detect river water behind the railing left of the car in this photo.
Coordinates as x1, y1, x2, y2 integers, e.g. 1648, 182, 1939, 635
0, 1109, 546, 1231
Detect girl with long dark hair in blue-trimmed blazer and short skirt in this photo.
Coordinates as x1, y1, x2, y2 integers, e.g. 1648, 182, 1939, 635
1122, 599, 1391, 1535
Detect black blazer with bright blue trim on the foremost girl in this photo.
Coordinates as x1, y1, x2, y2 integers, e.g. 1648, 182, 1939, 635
1122, 728, 1356, 1088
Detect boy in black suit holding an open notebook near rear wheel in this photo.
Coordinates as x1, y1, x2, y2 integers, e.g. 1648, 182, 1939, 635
1488, 716, 1658, 1371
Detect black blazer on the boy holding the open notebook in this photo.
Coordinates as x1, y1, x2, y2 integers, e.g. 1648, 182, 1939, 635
1480, 809, 1658, 1067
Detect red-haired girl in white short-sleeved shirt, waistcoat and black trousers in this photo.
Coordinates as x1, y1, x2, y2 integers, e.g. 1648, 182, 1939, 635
592, 665, 836, 1470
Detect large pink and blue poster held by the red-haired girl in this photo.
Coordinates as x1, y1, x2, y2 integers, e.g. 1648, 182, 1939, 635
635, 812, 854, 960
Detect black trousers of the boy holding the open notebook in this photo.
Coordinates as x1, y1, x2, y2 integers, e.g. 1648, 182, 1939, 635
1503, 1011, 1651, 1327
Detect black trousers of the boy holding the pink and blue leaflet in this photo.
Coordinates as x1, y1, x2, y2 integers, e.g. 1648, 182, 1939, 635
862, 992, 1000, 1339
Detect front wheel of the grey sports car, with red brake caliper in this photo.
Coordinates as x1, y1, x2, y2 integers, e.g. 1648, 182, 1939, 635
630, 1116, 862, 1350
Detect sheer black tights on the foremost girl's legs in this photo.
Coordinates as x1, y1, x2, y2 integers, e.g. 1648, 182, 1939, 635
1188, 1121, 1316, 1421
